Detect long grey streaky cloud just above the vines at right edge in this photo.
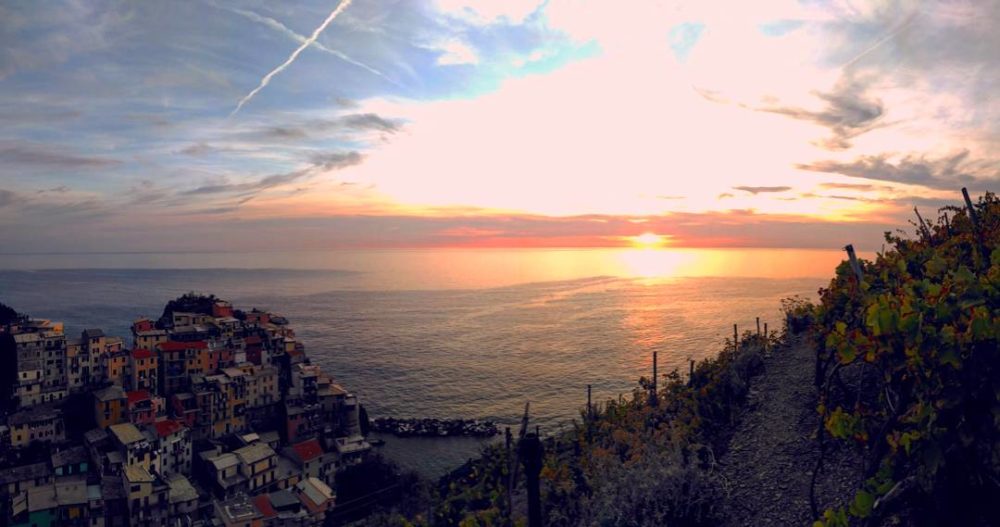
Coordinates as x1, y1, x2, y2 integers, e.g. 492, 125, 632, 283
797, 150, 1000, 190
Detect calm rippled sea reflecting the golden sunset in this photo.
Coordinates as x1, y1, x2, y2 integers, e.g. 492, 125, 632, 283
0, 249, 843, 478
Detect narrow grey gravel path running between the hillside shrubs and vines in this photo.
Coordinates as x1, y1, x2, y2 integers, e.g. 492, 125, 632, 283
721, 336, 861, 527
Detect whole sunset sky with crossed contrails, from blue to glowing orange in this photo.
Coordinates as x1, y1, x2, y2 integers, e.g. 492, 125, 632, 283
0, 0, 1000, 253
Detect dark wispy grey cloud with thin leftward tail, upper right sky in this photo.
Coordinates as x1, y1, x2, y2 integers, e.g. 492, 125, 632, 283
759, 82, 885, 150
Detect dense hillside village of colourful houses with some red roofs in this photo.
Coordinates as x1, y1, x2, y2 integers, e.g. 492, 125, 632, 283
0, 293, 372, 527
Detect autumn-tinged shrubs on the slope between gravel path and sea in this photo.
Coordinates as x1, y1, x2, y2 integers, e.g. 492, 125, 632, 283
426, 333, 777, 527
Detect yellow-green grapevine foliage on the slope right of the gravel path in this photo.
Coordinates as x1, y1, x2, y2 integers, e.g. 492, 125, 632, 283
812, 193, 1000, 526
